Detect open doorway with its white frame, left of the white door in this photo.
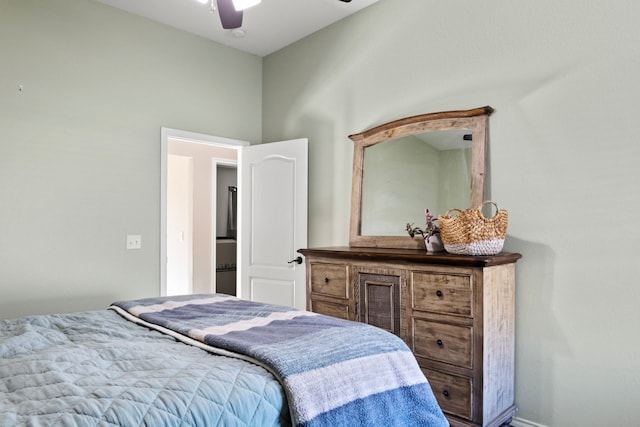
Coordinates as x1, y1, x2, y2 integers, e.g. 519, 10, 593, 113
160, 128, 249, 295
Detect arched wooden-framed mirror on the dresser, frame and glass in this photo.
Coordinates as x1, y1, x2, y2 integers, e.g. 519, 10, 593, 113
349, 106, 493, 248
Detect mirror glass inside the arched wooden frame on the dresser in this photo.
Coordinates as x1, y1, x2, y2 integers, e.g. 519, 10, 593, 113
360, 129, 471, 236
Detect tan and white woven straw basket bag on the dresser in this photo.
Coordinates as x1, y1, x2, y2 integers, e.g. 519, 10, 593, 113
438, 201, 509, 255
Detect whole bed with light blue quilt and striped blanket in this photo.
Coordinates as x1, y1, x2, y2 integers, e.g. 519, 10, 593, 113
0, 294, 449, 427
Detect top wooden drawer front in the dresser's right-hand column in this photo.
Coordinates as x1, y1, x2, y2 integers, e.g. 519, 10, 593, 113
411, 271, 473, 317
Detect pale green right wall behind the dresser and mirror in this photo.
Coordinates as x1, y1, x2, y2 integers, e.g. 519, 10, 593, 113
263, 0, 640, 427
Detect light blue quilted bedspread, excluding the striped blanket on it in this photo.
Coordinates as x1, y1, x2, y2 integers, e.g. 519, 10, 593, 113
0, 310, 291, 427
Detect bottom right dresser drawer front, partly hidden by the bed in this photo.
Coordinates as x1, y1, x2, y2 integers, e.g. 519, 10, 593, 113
422, 369, 472, 420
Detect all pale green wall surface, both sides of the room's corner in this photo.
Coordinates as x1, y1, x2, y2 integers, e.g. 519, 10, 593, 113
0, 0, 640, 427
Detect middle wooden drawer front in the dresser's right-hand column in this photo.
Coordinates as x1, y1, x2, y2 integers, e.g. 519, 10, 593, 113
413, 318, 473, 369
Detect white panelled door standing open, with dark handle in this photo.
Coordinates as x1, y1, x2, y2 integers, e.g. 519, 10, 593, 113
237, 139, 308, 309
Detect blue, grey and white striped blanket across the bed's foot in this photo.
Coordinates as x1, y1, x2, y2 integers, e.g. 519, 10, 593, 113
111, 294, 449, 427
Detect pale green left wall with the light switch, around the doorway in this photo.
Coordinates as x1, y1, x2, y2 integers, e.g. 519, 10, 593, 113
0, 0, 262, 318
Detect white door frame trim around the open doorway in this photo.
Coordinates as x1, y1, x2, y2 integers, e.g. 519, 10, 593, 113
160, 127, 250, 295
